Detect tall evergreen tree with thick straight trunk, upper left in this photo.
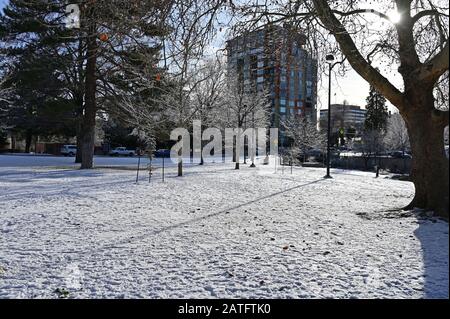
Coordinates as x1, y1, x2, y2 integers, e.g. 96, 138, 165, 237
0, 0, 169, 168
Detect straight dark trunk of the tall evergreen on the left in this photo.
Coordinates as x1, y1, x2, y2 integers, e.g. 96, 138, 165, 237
81, 23, 97, 169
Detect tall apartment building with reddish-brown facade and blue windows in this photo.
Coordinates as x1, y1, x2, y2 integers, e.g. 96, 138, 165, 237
227, 25, 317, 145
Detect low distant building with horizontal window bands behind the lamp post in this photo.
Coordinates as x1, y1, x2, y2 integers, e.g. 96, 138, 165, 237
319, 104, 367, 135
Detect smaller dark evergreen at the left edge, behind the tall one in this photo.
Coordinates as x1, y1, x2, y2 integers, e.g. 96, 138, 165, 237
0, 51, 75, 152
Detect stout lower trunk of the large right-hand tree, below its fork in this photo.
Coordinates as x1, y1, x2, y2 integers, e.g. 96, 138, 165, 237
403, 93, 449, 218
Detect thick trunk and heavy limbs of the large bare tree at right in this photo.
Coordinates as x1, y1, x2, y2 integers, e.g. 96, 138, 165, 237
313, 0, 450, 218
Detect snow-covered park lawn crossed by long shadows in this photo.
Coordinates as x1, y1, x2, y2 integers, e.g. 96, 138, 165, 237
0, 158, 449, 298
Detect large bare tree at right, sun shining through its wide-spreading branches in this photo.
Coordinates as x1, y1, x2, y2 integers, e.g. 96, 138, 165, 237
227, 0, 449, 217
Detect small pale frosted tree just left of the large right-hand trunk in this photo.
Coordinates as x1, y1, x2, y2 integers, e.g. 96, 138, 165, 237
384, 114, 410, 154
